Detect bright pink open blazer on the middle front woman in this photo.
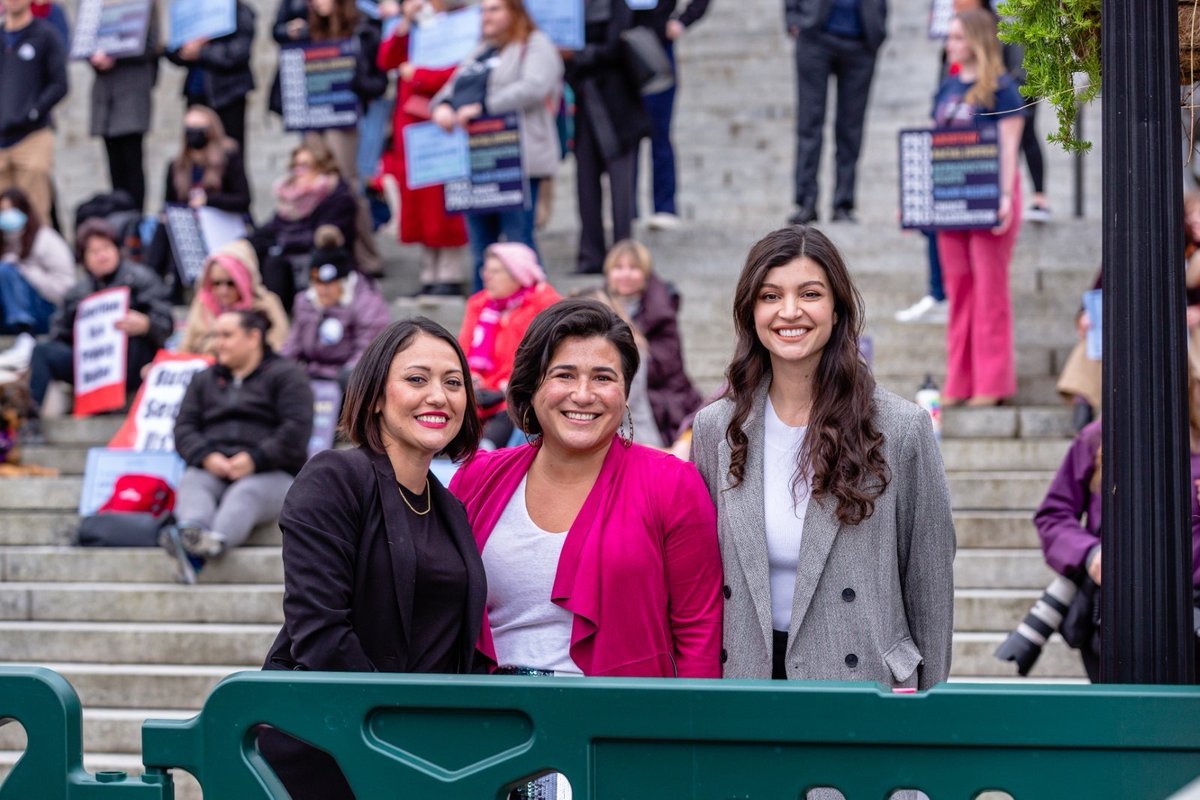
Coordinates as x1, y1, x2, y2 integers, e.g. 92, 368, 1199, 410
450, 439, 722, 678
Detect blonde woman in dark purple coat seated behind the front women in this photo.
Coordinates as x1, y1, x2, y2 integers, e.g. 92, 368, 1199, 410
604, 239, 703, 443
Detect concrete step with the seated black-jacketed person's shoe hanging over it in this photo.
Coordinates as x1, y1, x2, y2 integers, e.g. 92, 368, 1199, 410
0, 547, 283, 584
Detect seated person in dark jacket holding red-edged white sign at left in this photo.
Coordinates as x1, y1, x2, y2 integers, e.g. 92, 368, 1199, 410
25, 219, 175, 441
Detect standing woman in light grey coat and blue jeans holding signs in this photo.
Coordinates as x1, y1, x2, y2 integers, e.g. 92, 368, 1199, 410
433, 0, 563, 284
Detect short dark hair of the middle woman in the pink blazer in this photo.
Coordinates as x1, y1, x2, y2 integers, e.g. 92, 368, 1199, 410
508, 297, 641, 435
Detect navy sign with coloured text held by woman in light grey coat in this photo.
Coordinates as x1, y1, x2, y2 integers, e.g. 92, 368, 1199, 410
445, 113, 529, 213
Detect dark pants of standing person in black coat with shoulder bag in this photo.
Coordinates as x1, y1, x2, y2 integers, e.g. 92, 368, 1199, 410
575, 95, 637, 272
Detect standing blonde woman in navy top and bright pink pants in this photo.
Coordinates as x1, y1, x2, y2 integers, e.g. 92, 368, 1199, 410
934, 11, 1025, 405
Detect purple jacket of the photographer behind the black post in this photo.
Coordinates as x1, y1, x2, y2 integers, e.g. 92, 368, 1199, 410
1033, 420, 1200, 587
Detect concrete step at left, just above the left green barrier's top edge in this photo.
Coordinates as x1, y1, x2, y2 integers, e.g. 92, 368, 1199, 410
0, 621, 280, 667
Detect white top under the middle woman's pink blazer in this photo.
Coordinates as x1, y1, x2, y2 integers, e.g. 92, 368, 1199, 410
482, 479, 583, 675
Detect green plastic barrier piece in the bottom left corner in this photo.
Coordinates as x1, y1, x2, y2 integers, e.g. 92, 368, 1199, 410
0, 667, 175, 800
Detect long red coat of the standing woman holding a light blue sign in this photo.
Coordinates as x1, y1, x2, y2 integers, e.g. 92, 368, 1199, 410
377, 35, 467, 247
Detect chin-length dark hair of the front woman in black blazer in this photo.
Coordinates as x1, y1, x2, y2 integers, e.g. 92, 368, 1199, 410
338, 317, 484, 461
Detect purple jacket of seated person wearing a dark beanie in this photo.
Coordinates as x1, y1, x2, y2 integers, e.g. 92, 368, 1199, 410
281, 272, 391, 380
